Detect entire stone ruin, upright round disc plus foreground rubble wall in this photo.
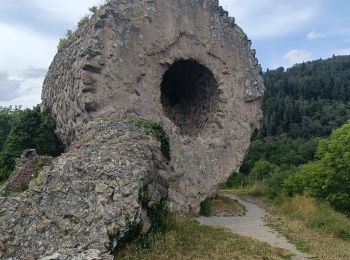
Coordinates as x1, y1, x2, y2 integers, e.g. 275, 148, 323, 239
0, 0, 264, 259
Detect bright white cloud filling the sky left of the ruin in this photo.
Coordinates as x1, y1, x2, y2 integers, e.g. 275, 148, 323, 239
0, 0, 104, 107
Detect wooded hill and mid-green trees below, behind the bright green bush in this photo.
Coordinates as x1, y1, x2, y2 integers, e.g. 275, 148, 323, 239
241, 56, 350, 174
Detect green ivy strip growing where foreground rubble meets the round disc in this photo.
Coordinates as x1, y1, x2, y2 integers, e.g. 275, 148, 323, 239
131, 118, 170, 161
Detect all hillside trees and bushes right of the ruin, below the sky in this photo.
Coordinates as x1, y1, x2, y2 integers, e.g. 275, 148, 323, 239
227, 56, 350, 213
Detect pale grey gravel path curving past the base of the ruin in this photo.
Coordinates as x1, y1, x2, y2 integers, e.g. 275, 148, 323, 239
197, 194, 310, 260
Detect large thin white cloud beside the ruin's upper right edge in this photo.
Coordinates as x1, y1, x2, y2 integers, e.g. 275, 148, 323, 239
220, 0, 322, 39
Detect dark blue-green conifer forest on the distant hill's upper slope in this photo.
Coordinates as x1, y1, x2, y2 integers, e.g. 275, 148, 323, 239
261, 56, 350, 138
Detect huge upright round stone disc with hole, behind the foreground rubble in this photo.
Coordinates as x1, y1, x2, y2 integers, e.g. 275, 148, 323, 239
42, 0, 264, 211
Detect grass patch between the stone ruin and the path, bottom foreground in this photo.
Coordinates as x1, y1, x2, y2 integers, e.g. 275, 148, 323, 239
115, 216, 290, 260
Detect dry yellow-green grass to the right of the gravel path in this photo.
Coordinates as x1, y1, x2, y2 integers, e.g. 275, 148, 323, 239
267, 196, 350, 260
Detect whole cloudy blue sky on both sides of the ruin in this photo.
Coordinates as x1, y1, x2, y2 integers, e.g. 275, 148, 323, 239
0, 0, 350, 108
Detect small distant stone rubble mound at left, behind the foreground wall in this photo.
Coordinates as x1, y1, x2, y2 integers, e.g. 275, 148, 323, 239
4, 150, 53, 192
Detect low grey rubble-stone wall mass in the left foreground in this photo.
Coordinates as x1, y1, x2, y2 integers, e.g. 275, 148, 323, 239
0, 121, 168, 260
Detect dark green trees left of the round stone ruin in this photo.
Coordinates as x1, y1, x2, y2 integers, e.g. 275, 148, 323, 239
0, 106, 64, 181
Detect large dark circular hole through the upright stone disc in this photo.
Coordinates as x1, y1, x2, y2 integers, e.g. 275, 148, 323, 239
161, 60, 218, 135
